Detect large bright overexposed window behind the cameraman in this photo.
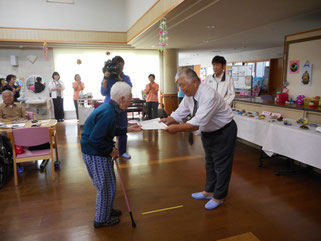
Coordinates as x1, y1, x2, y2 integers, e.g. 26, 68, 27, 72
53, 49, 160, 110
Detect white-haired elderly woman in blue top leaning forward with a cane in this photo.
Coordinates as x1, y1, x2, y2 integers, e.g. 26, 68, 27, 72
80, 82, 141, 228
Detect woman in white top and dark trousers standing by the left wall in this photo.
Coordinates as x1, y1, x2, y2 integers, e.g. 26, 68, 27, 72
48, 72, 65, 122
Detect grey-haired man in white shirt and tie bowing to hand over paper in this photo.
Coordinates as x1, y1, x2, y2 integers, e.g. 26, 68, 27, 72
161, 69, 237, 210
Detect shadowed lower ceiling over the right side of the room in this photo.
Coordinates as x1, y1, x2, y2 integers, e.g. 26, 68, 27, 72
130, 0, 321, 54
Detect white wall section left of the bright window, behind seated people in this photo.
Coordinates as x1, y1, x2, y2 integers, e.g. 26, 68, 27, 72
0, 49, 54, 89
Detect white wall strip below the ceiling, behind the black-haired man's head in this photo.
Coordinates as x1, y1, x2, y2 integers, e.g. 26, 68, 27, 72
178, 47, 283, 74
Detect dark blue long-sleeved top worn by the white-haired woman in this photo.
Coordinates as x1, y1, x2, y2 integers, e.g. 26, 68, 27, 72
80, 100, 127, 157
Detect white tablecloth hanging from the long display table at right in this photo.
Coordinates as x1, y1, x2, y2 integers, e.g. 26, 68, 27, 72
234, 114, 321, 169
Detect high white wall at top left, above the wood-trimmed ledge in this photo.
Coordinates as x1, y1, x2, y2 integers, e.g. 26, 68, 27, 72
0, 0, 156, 32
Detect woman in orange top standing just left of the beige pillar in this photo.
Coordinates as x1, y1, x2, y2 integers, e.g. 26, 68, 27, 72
145, 74, 159, 119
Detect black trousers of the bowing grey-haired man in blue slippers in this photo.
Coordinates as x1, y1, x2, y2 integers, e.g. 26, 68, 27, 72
202, 120, 237, 199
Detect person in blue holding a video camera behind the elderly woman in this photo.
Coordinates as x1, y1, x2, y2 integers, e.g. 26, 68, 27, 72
100, 56, 133, 159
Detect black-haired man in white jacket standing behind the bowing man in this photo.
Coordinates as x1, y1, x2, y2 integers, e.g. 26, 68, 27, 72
204, 55, 235, 105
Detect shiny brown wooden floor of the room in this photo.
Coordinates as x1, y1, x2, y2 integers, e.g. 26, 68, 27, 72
0, 121, 321, 241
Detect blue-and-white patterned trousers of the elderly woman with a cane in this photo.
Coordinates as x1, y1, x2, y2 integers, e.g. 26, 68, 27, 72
82, 153, 116, 223
